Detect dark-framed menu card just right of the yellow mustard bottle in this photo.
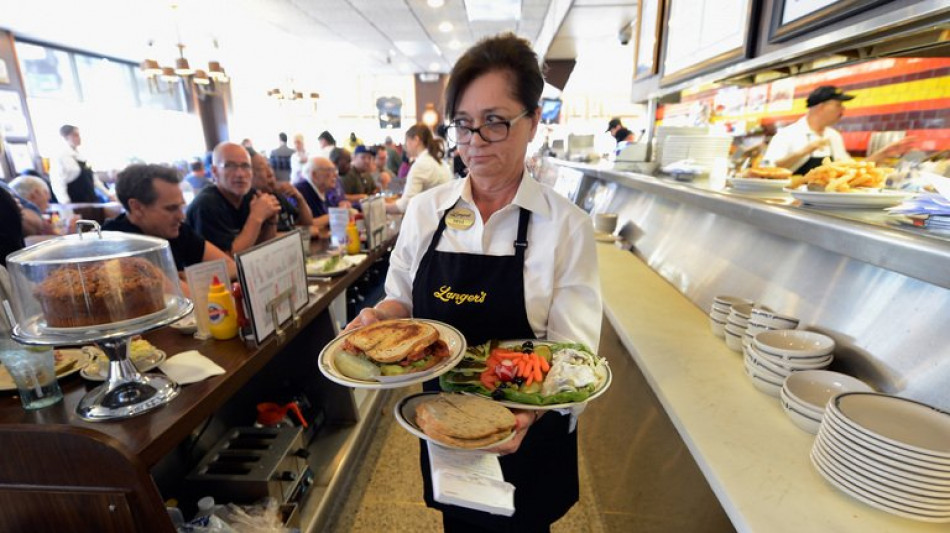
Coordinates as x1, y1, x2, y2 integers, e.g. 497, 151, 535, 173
234, 232, 310, 343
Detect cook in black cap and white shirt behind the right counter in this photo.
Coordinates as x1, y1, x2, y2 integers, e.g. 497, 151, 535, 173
763, 85, 913, 174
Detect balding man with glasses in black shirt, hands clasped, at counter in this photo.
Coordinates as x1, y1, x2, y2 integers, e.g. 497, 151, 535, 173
186, 142, 280, 255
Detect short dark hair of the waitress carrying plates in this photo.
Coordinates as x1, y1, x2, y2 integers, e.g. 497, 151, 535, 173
445, 32, 544, 119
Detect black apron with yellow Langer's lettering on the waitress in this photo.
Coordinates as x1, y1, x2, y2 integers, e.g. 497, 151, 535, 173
412, 203, 578, 532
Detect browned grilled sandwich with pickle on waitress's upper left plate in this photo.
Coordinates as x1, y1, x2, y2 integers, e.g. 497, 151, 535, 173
334, 320, 449, 380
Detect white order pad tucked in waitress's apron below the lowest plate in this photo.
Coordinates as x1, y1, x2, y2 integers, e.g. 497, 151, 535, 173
426, 442, 515, 516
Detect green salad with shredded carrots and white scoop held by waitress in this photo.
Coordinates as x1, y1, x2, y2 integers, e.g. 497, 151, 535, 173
440, 341, 608, 405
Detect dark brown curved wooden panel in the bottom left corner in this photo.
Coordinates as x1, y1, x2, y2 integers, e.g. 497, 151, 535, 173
0, 424, 175, 533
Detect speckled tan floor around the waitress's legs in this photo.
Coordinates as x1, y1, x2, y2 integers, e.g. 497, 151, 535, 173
329, 388, 605, 533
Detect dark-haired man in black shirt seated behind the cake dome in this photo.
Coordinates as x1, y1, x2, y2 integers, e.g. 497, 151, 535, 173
102, 165, 237, 293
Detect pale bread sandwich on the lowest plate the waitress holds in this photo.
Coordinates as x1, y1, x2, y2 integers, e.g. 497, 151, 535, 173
416, 394, 516, 448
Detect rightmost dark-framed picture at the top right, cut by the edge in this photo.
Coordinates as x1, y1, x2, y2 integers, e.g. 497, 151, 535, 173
769, 0, 890, 43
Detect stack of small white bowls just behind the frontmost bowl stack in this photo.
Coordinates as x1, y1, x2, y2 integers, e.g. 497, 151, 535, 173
745, 329, 835, 398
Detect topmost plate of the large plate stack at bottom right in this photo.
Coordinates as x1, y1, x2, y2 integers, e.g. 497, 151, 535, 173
830, 392, 950, 464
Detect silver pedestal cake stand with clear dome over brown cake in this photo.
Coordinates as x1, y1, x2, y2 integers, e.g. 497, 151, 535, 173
7, 221, 194, 421
